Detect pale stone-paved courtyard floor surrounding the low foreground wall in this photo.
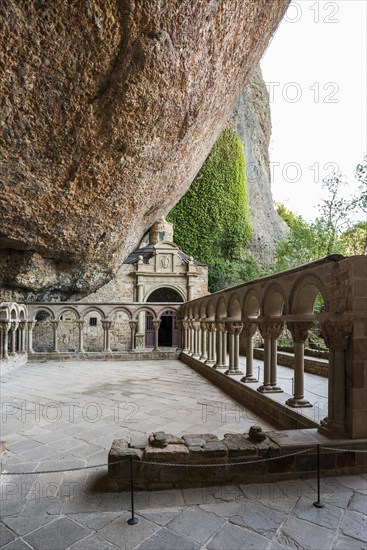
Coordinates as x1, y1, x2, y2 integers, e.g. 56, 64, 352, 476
0, 361, 367, 550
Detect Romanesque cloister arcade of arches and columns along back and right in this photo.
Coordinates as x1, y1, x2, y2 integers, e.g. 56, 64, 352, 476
0, 256, 367, 439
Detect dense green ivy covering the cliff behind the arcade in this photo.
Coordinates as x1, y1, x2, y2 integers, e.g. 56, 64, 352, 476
167, 127, 255, 292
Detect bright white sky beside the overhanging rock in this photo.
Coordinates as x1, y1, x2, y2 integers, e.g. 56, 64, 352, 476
261, 0, 367, 221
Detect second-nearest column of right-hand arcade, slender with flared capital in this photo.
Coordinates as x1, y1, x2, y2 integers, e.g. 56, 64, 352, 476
286, 322, 313, 408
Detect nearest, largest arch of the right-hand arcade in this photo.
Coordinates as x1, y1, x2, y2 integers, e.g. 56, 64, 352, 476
288, 273, 329, 314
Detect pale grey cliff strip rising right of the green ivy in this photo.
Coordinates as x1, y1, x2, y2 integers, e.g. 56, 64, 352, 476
232, 67, 287, 263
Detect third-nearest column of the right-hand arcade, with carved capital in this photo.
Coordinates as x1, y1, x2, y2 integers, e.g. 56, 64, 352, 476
257, 319, 284, 393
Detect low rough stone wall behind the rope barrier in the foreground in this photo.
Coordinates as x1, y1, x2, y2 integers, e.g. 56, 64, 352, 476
108, 432, 367, 491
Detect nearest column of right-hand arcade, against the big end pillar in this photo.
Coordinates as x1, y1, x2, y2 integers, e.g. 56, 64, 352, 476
319, 321, 352, 437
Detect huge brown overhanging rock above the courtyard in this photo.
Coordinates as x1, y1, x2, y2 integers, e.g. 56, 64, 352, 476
0, 0, 289, 299
